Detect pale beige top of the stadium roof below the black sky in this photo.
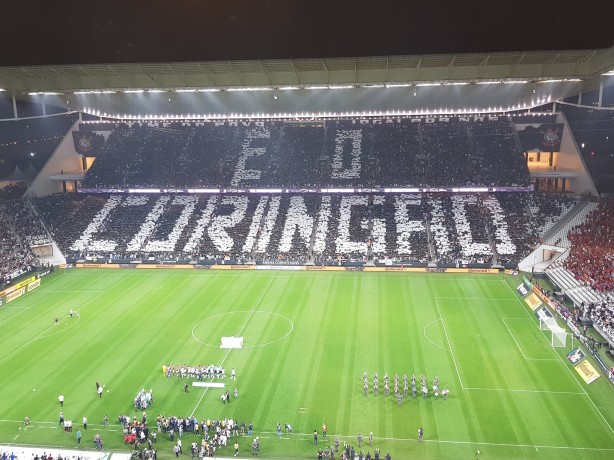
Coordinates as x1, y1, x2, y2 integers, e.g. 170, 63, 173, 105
0, 47, 614, 94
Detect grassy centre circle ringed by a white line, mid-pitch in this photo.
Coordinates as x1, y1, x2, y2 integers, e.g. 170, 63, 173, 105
192, 310, 294, 348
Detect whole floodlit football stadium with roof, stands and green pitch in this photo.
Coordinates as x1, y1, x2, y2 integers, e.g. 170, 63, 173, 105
0, 2, 614, 460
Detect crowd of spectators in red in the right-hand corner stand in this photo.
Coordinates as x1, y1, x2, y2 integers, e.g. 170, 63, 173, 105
565, 201, 614, 293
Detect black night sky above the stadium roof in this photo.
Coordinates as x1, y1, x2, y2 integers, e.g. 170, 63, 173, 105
0, 0, 614, 66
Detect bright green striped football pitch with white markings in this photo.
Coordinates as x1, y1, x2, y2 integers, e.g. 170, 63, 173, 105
0, 269, 614, 459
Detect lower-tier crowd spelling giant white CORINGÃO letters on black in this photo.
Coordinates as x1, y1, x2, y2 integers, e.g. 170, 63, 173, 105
28, 193, 580, 264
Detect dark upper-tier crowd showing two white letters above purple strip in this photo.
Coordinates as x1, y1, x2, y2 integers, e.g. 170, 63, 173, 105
80, 118, 529, 188
